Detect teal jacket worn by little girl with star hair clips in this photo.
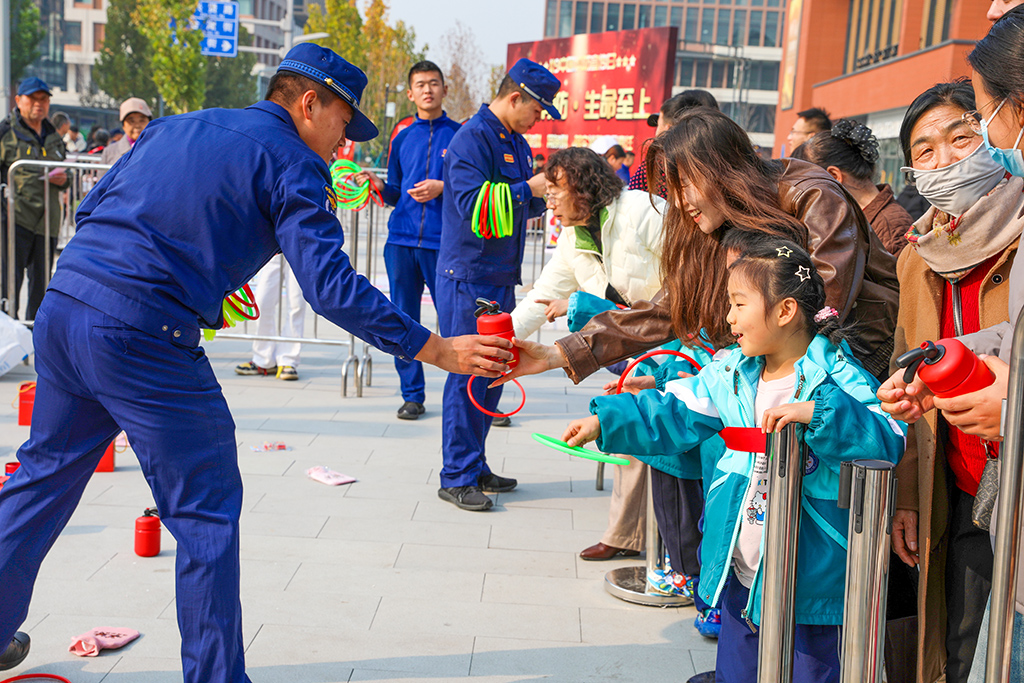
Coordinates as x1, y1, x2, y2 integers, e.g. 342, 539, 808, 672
590, 336, 905, 625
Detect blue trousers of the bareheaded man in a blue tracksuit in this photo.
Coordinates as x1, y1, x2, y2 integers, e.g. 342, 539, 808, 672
384, 244, 437, 403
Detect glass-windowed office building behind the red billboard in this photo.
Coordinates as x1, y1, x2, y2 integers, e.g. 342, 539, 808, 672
544, 0, 788, 153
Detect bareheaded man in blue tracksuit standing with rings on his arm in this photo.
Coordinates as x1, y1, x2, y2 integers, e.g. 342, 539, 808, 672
361, 61, 459, 420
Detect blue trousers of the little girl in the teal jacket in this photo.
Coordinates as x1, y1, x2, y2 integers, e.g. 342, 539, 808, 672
715, 573, 843, 683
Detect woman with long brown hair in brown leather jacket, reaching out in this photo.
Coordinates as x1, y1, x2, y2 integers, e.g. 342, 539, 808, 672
502, 109, 899, 383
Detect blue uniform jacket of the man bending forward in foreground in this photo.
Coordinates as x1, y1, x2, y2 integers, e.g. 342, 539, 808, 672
50, 101, 430, 357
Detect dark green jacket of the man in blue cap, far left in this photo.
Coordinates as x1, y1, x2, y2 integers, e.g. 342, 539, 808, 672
0, 109, 71, 238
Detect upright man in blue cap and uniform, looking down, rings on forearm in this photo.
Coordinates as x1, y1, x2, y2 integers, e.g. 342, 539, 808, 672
434, 59, 561, 510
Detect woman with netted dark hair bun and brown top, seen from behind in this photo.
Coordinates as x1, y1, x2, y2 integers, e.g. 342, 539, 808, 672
793, 119, 913, 254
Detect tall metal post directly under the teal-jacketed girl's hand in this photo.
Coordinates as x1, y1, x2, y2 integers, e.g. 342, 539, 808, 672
758, 424, 807, 683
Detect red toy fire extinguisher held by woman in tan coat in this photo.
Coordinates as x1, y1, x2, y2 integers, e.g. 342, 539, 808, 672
896, 339, 995, 398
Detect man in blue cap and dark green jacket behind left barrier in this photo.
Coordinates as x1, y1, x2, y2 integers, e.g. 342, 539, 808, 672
0, 78, 69, 321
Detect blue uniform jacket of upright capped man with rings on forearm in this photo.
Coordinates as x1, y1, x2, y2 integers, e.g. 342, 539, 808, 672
437, 104, 544, 287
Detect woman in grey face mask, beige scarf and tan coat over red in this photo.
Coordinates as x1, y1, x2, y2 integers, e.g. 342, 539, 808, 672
879, 81, 1024, 683
